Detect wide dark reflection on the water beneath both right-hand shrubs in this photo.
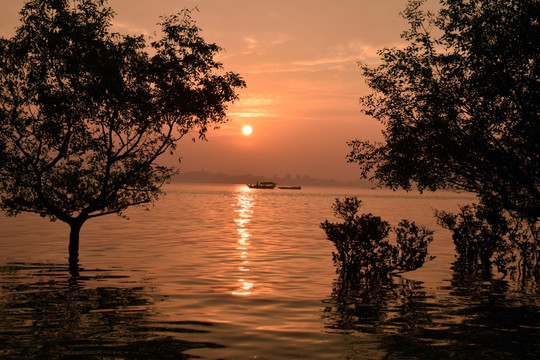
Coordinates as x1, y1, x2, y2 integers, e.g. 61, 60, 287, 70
323, 263, 540, 359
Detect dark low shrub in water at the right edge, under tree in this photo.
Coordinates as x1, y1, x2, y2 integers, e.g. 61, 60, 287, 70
436, 201, 540, 280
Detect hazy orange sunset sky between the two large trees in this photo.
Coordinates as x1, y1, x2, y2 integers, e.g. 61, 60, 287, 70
0, 0, 433, 180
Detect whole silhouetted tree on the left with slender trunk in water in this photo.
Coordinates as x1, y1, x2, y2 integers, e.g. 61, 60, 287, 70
0, 0, 245, 268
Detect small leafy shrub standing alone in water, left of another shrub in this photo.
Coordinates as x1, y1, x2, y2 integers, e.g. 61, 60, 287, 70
321, 197, 433, 283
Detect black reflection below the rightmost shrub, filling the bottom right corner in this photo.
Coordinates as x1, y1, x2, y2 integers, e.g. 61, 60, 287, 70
385, 262, 540, 359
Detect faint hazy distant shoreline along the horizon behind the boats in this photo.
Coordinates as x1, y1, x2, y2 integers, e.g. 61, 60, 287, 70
171, 170, 374, 188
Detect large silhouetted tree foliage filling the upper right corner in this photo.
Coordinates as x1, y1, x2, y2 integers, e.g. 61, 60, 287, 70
348, 0, 540, 218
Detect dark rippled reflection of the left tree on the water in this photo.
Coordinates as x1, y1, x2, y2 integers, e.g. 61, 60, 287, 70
0, 264, 224, 359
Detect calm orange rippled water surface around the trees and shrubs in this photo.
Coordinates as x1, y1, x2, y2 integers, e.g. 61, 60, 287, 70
0, 184, 540, 359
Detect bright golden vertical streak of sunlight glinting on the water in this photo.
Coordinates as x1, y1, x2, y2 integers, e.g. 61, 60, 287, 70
232, 187, 255, 296
